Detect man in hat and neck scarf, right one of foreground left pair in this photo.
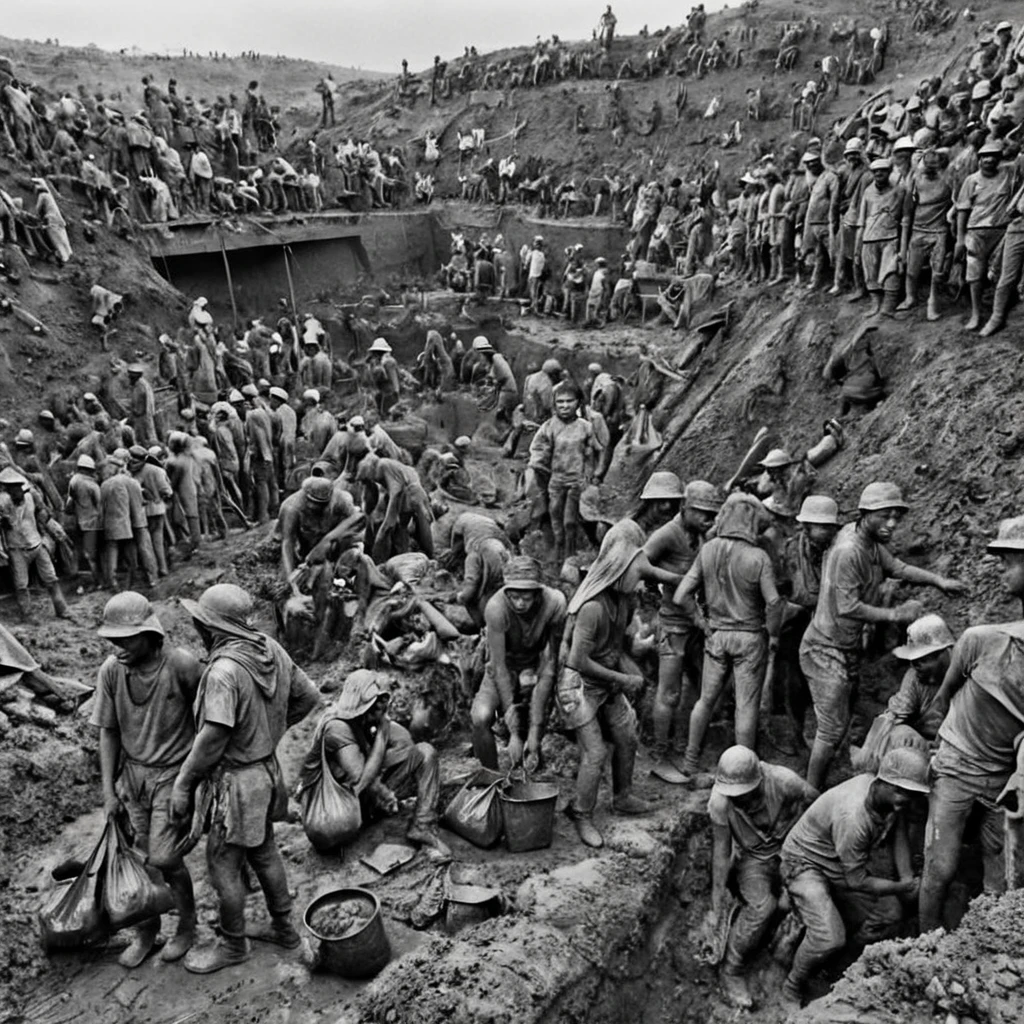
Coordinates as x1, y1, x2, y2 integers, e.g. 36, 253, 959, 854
170, 583, 319, 974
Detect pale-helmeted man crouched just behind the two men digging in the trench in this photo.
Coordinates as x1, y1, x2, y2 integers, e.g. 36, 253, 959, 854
850, 614, 956, 771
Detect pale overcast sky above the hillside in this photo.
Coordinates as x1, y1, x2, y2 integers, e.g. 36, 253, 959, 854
8, 0, 738, 71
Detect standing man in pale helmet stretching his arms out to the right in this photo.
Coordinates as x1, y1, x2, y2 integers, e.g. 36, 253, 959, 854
800, 481, 967, 790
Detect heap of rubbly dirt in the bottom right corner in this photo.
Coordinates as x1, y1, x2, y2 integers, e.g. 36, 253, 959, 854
790, 890, 1024, 1024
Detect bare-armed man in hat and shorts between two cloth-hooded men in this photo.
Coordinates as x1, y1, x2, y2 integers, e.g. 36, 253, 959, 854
643, 480, 722, 785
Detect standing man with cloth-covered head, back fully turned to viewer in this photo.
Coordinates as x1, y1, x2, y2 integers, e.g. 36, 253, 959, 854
674, 492, 784, 778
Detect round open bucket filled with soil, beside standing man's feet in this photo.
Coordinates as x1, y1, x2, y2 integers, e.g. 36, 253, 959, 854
302, 889, 391, 978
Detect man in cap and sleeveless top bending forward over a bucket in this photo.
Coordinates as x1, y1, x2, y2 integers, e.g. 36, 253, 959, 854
470, 555, 565, 771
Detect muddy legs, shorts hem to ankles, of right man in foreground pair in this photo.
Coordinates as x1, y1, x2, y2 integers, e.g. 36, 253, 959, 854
206, 821, 292, 938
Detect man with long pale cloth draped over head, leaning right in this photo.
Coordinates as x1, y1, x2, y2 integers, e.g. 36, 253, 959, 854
555, 525, 650, 848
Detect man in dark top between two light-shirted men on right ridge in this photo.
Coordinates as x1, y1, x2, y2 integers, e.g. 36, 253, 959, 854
896, 150, 953, 321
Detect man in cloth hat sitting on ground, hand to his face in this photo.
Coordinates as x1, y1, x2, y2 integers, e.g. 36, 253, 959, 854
299, 669, 452, 860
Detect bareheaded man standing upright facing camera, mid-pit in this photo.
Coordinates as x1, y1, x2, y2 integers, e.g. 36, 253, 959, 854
529, 381, 600, 562
